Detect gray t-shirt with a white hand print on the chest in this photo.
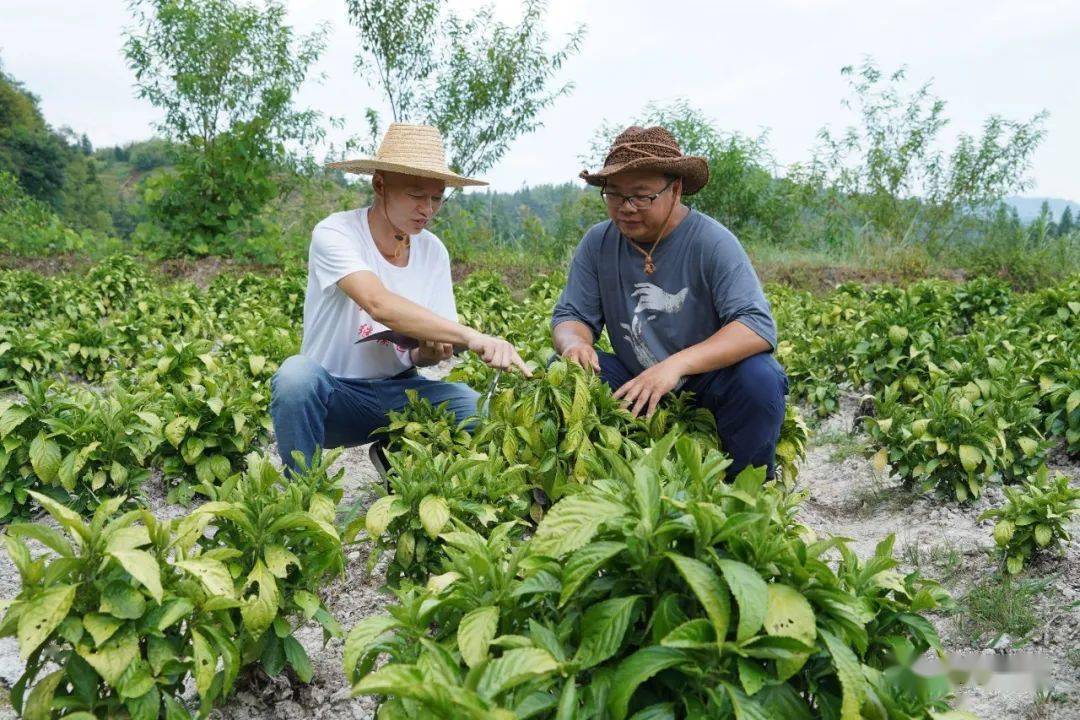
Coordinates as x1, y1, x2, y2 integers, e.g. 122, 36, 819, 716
551, 209, 777, 376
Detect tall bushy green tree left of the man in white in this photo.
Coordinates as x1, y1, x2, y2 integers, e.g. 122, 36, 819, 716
124, 0, 325, 254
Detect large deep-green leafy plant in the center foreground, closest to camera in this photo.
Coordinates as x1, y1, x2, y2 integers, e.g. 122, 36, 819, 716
345, 435, 948, 719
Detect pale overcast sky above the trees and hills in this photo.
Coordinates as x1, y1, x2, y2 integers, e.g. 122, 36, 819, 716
6, 0, 1080, 200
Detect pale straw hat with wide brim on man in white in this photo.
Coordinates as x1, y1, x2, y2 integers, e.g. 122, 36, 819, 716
326, 122, 487, 188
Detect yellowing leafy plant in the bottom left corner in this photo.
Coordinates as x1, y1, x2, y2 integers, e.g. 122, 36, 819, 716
0, 493, 217, 718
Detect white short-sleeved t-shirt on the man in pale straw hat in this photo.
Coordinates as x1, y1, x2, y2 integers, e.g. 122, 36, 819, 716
300, 207, 458, 379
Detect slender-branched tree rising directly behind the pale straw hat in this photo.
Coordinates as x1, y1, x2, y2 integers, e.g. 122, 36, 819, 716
347, 0, 584, 175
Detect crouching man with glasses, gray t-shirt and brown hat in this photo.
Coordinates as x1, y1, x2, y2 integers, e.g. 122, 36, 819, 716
552, 126, 787, 477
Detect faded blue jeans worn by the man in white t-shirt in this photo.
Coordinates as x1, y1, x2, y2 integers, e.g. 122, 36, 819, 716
270, 355, 480, 479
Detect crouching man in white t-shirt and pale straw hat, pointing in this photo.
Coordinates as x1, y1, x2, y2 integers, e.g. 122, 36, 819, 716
270, 123, 529, 479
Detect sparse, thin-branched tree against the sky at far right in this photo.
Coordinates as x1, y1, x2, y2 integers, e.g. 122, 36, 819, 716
804, 59, 1047, 248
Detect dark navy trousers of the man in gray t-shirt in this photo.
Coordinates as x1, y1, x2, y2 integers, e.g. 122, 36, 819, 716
596, 351, 787, 478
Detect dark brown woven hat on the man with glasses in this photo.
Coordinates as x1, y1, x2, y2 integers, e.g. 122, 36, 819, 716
578, 125, 708, 195
